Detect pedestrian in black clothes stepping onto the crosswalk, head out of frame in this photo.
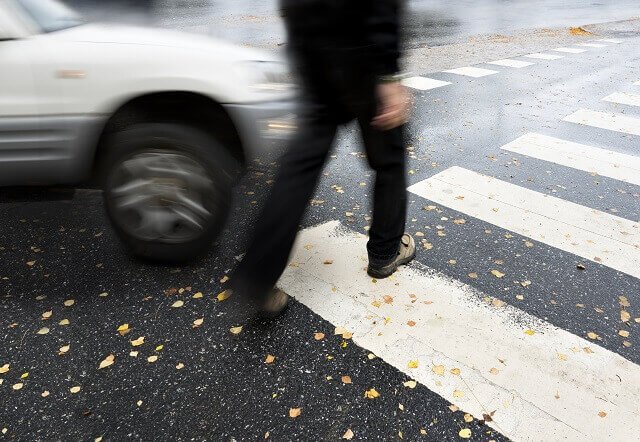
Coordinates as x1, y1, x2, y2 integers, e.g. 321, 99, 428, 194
232, 0, 415, 316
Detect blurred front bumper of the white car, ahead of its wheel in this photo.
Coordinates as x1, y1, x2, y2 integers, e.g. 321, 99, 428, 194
225, 100, 297, 159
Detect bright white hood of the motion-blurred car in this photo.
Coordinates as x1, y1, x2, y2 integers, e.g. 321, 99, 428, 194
55, 23, 278, 61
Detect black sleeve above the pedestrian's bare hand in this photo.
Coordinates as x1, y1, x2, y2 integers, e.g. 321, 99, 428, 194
366, 0, 403, 75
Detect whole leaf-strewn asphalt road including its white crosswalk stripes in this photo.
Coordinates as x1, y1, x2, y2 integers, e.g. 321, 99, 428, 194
0, 6, 640, 441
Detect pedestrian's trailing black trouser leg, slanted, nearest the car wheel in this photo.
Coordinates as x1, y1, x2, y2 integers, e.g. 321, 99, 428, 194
232, 117, 337, 300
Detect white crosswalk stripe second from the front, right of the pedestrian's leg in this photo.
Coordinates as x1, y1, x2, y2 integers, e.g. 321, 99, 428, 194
409, 167, 640, 278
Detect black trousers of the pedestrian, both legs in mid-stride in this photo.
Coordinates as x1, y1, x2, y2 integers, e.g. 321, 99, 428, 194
232, 93, 407, 299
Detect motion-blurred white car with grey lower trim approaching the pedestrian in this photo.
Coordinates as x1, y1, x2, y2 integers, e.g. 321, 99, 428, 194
0, 0, 295, 261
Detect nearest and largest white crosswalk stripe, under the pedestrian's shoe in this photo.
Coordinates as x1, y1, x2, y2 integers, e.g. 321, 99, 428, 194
279, 221, 640, 442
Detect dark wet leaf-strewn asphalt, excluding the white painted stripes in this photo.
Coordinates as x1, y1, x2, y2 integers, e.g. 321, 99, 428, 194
0, 3, 640, 441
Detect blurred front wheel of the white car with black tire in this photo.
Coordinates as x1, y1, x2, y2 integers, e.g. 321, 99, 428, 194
102, 123, 237, 264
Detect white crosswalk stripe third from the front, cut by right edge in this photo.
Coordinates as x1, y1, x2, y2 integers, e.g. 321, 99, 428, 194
502, 133, 640, 186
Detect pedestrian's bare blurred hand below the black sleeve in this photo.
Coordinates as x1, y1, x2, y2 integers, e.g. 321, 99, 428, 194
371, 81, 411, 130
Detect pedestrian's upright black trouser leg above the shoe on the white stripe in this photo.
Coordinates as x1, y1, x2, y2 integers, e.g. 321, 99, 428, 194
358, 118, 407, 264
